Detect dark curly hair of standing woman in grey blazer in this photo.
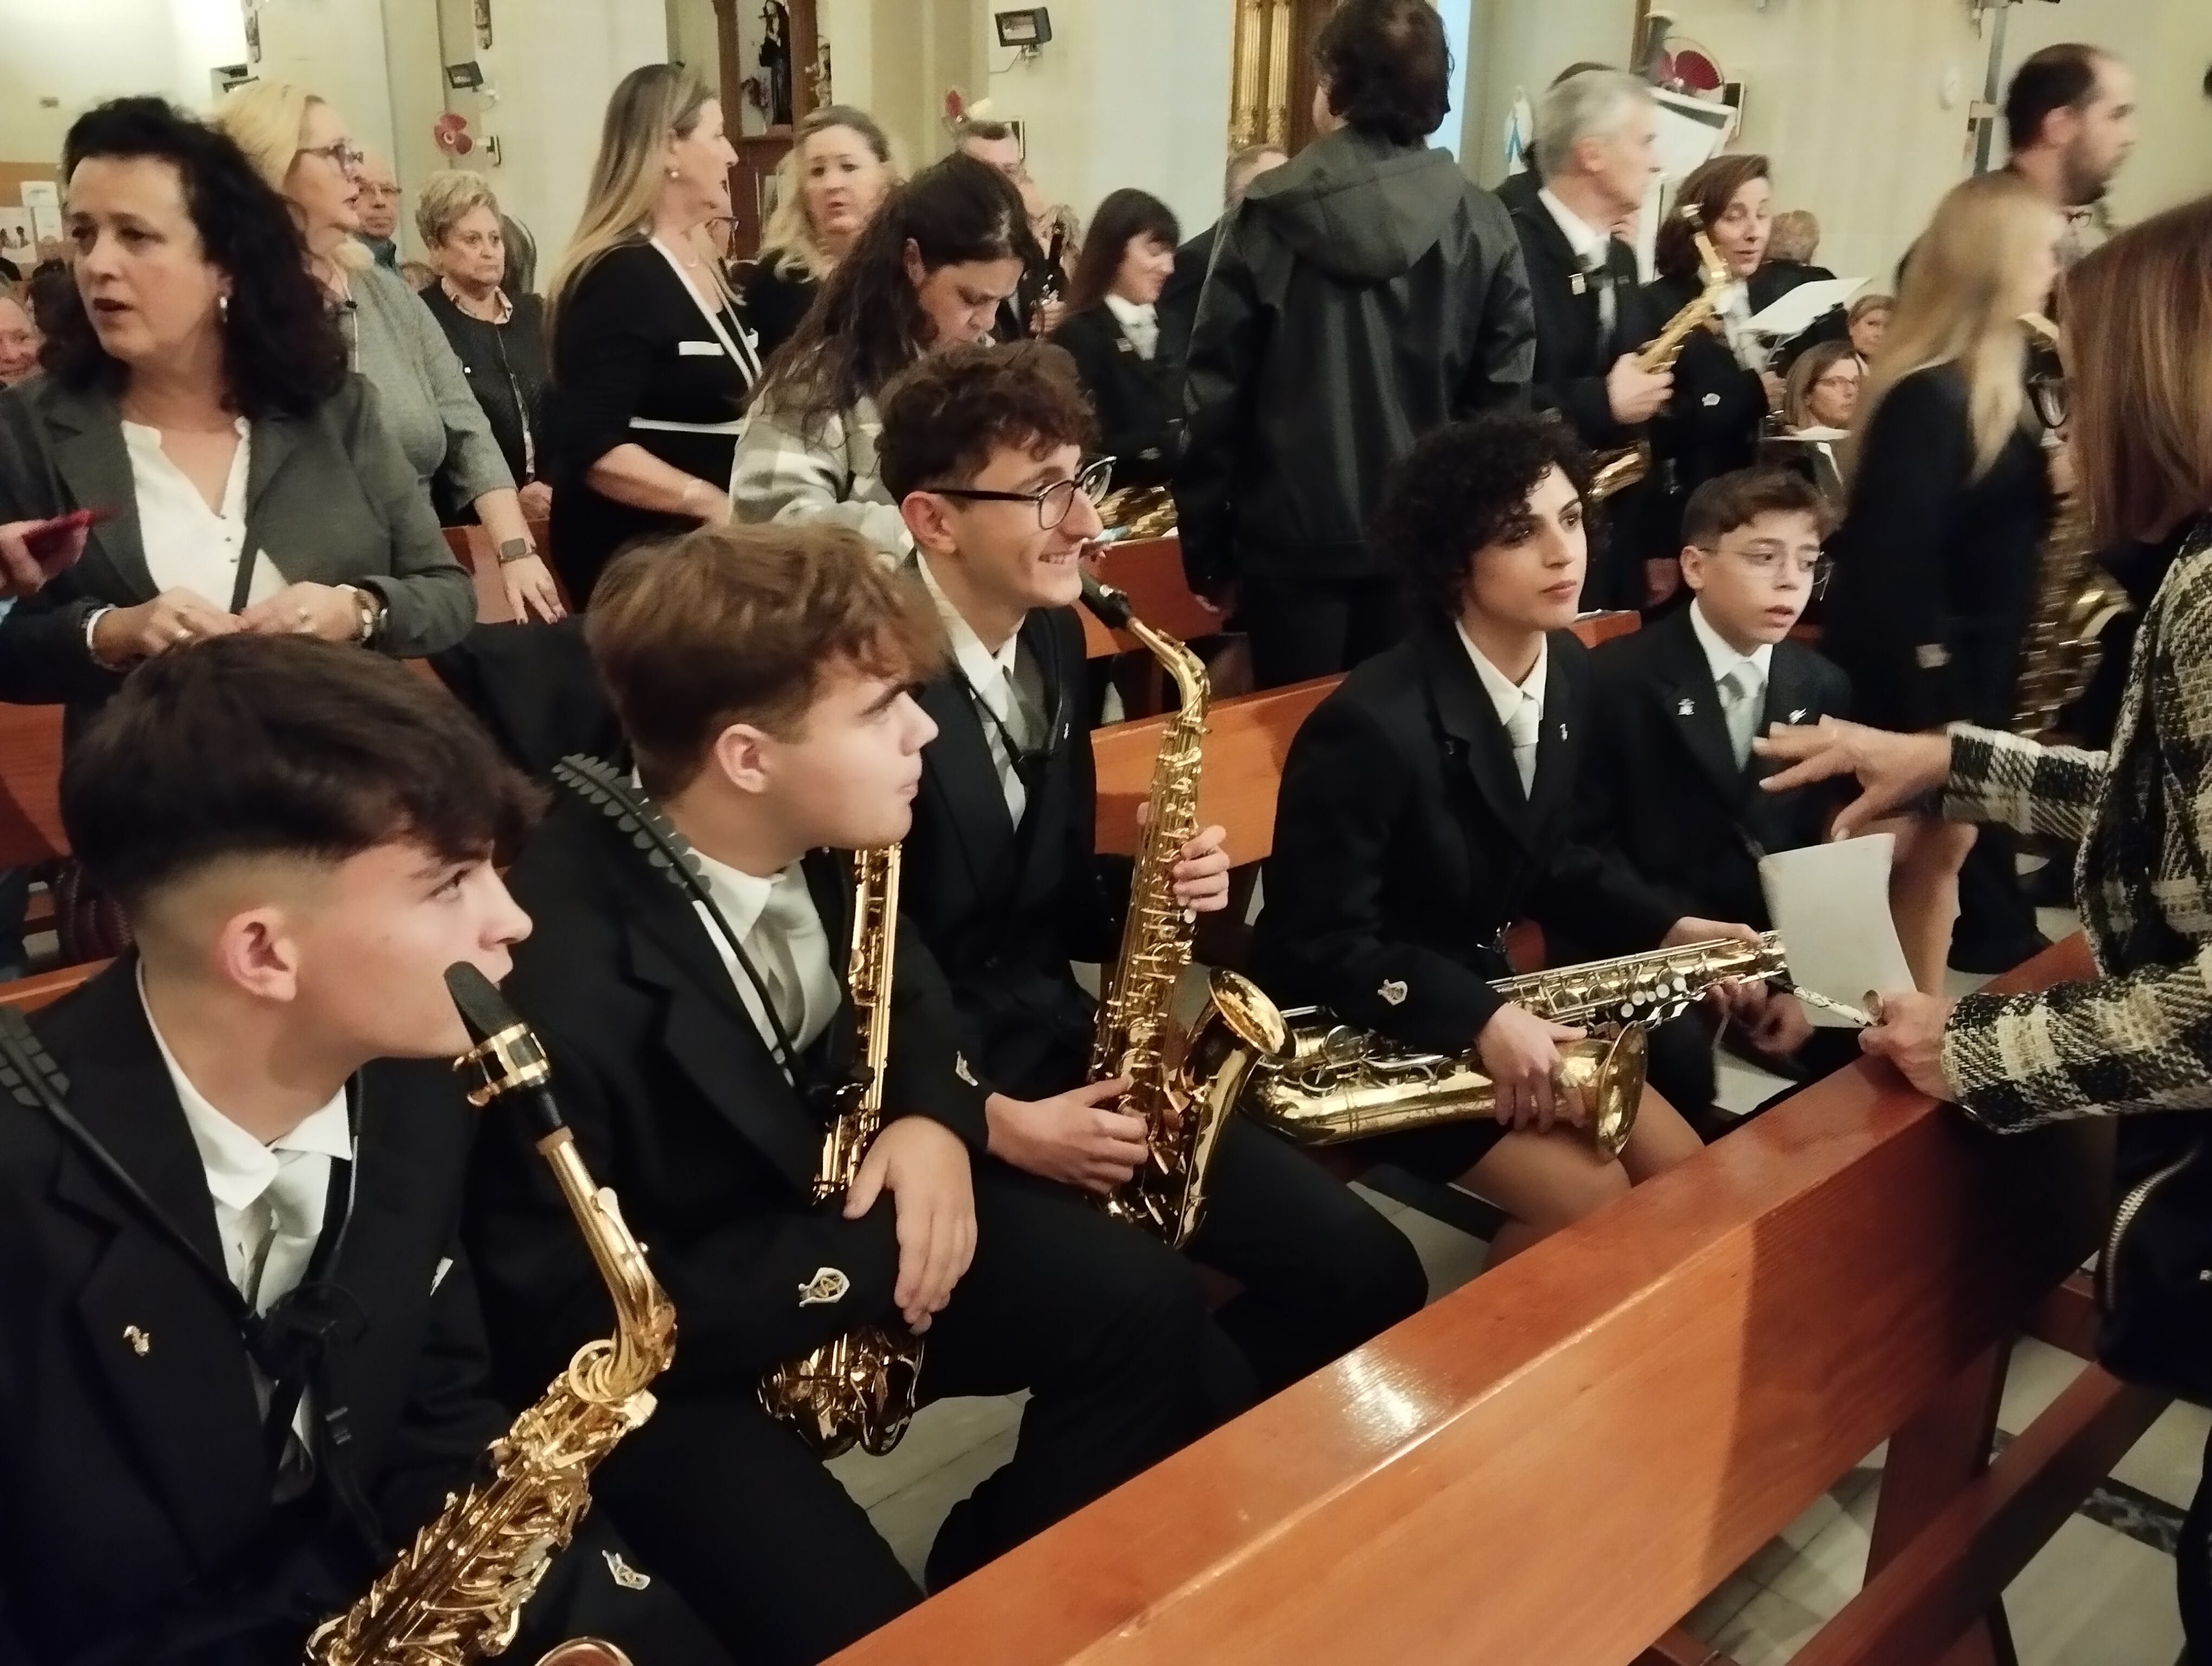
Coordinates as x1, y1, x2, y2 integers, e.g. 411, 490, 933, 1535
40, 98, 348, 420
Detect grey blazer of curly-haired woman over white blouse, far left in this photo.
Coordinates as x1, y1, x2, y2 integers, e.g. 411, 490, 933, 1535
0, 376, 475, 706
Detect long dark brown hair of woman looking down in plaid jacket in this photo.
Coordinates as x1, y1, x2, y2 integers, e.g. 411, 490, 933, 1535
752, 150, 1035, 438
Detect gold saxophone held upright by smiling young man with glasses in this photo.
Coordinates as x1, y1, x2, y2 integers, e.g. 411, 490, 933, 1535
1084, 573, 1288, 1246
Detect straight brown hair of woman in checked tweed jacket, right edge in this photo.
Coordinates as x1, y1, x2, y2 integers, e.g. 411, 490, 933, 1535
2066, 197, 2212, 542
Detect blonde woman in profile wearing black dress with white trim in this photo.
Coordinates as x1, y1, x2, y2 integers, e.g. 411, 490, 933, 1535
546, 64, 761, 606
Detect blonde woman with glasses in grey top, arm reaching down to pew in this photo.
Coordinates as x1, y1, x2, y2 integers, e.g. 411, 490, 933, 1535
215, 82, 564, 619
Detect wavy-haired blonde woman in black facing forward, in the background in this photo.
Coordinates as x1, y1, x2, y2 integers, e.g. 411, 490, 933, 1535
739, 104, 898, 363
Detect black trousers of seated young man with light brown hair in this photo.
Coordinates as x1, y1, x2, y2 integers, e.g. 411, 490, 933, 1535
593, 1162, 1250, 1666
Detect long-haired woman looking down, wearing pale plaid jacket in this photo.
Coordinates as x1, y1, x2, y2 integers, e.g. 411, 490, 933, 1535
730, 155, 1024, 560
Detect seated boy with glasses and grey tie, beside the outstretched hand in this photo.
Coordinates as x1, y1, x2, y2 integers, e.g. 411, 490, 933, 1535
1581, 469, 1856, 1115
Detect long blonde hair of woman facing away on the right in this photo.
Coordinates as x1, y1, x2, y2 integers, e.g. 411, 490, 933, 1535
1845, 172, 2057, 480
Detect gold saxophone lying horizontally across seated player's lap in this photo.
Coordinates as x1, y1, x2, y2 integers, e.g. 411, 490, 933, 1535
1245, 932, 1790, 1157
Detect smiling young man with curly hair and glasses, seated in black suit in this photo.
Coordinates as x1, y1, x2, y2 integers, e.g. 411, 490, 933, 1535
878, 345, 1427, 1392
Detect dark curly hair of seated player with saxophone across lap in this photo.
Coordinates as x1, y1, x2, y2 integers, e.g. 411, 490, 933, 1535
1367, 412, 1591, 624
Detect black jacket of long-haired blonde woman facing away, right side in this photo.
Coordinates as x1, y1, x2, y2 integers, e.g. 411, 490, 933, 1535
1823, 365, 2053, 730
